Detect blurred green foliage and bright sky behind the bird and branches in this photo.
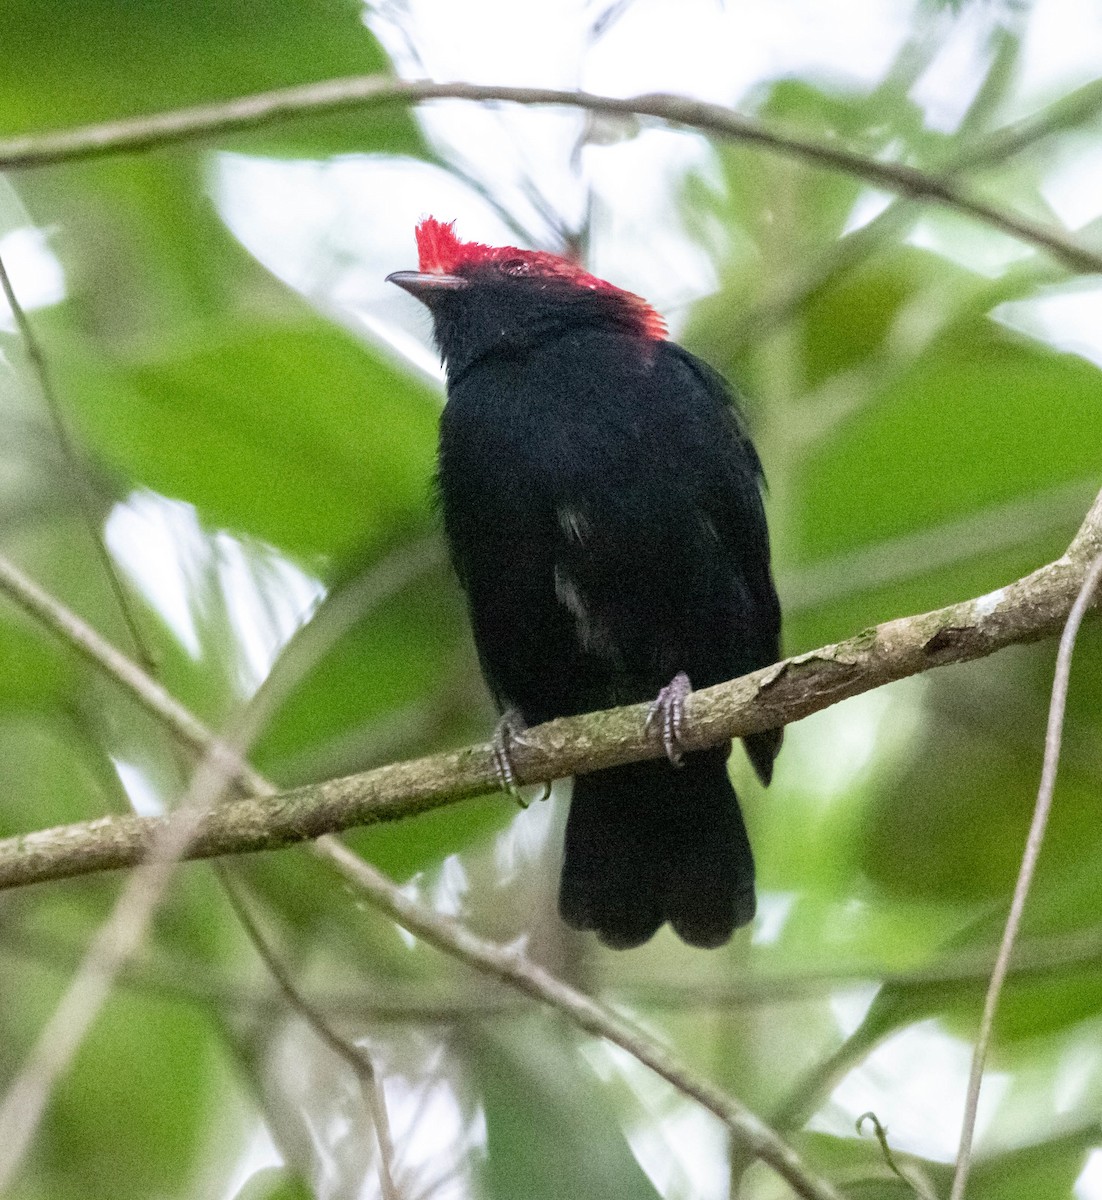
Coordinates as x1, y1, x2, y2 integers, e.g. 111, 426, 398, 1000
0, 0, 1102, 1200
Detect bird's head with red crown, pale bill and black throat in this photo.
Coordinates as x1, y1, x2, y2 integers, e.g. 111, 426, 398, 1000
387, 217, 666, 377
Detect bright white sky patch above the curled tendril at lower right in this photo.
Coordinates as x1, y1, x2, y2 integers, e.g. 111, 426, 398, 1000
809, 1020, 1010, 1163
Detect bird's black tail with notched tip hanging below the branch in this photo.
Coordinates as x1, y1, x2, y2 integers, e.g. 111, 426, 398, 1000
558, 746, 754, 949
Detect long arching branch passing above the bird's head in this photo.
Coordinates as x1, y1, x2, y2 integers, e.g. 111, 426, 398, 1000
0, 76, 1102, 274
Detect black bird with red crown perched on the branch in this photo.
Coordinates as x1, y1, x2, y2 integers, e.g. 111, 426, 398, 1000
388, 217, 781, 948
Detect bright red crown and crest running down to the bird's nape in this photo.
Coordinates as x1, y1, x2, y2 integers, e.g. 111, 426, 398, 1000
417, 217, 666, 338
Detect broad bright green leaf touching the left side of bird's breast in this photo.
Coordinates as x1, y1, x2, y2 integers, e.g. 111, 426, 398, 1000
59, 317, 438, 560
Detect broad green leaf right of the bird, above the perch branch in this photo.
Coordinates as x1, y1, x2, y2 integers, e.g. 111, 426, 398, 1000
799, 322, 1102, 559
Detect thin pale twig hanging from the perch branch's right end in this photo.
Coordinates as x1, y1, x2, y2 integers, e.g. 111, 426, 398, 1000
950, 553, 1102, 1200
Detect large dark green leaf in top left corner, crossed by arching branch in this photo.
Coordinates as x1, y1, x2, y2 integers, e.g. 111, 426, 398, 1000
0, 0, 423, 154
